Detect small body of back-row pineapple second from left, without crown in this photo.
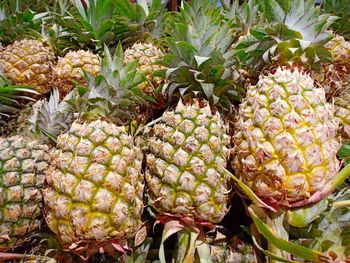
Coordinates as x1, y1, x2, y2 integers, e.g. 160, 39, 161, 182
53, 50, 101, 96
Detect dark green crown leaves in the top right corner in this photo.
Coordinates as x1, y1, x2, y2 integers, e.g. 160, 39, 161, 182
322, 0, 350, 40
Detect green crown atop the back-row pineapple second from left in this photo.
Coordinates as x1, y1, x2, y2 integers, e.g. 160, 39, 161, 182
53, 0, 121, 50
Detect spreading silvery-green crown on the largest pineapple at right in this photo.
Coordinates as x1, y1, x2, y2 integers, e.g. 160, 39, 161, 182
235, 0, 337, 71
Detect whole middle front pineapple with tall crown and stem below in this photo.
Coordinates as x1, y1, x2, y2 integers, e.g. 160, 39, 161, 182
146, 0, 241, 262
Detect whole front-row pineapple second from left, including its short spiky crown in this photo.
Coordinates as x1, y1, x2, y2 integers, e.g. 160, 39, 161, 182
44, 45, 145, 256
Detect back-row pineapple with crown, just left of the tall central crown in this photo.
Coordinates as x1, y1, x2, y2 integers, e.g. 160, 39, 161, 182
116, 0, 167, 99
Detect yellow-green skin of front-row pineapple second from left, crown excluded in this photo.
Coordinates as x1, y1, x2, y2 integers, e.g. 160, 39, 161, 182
44, 120, 144, 249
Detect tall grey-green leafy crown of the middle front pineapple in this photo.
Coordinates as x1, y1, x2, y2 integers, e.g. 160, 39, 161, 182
163, 0, 240, 111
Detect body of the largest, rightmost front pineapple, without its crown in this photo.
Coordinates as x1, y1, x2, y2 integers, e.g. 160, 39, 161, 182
233, 68, 340, 206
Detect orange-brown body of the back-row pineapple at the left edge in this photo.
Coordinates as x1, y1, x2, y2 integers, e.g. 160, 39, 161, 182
0, 39, 55, 94
